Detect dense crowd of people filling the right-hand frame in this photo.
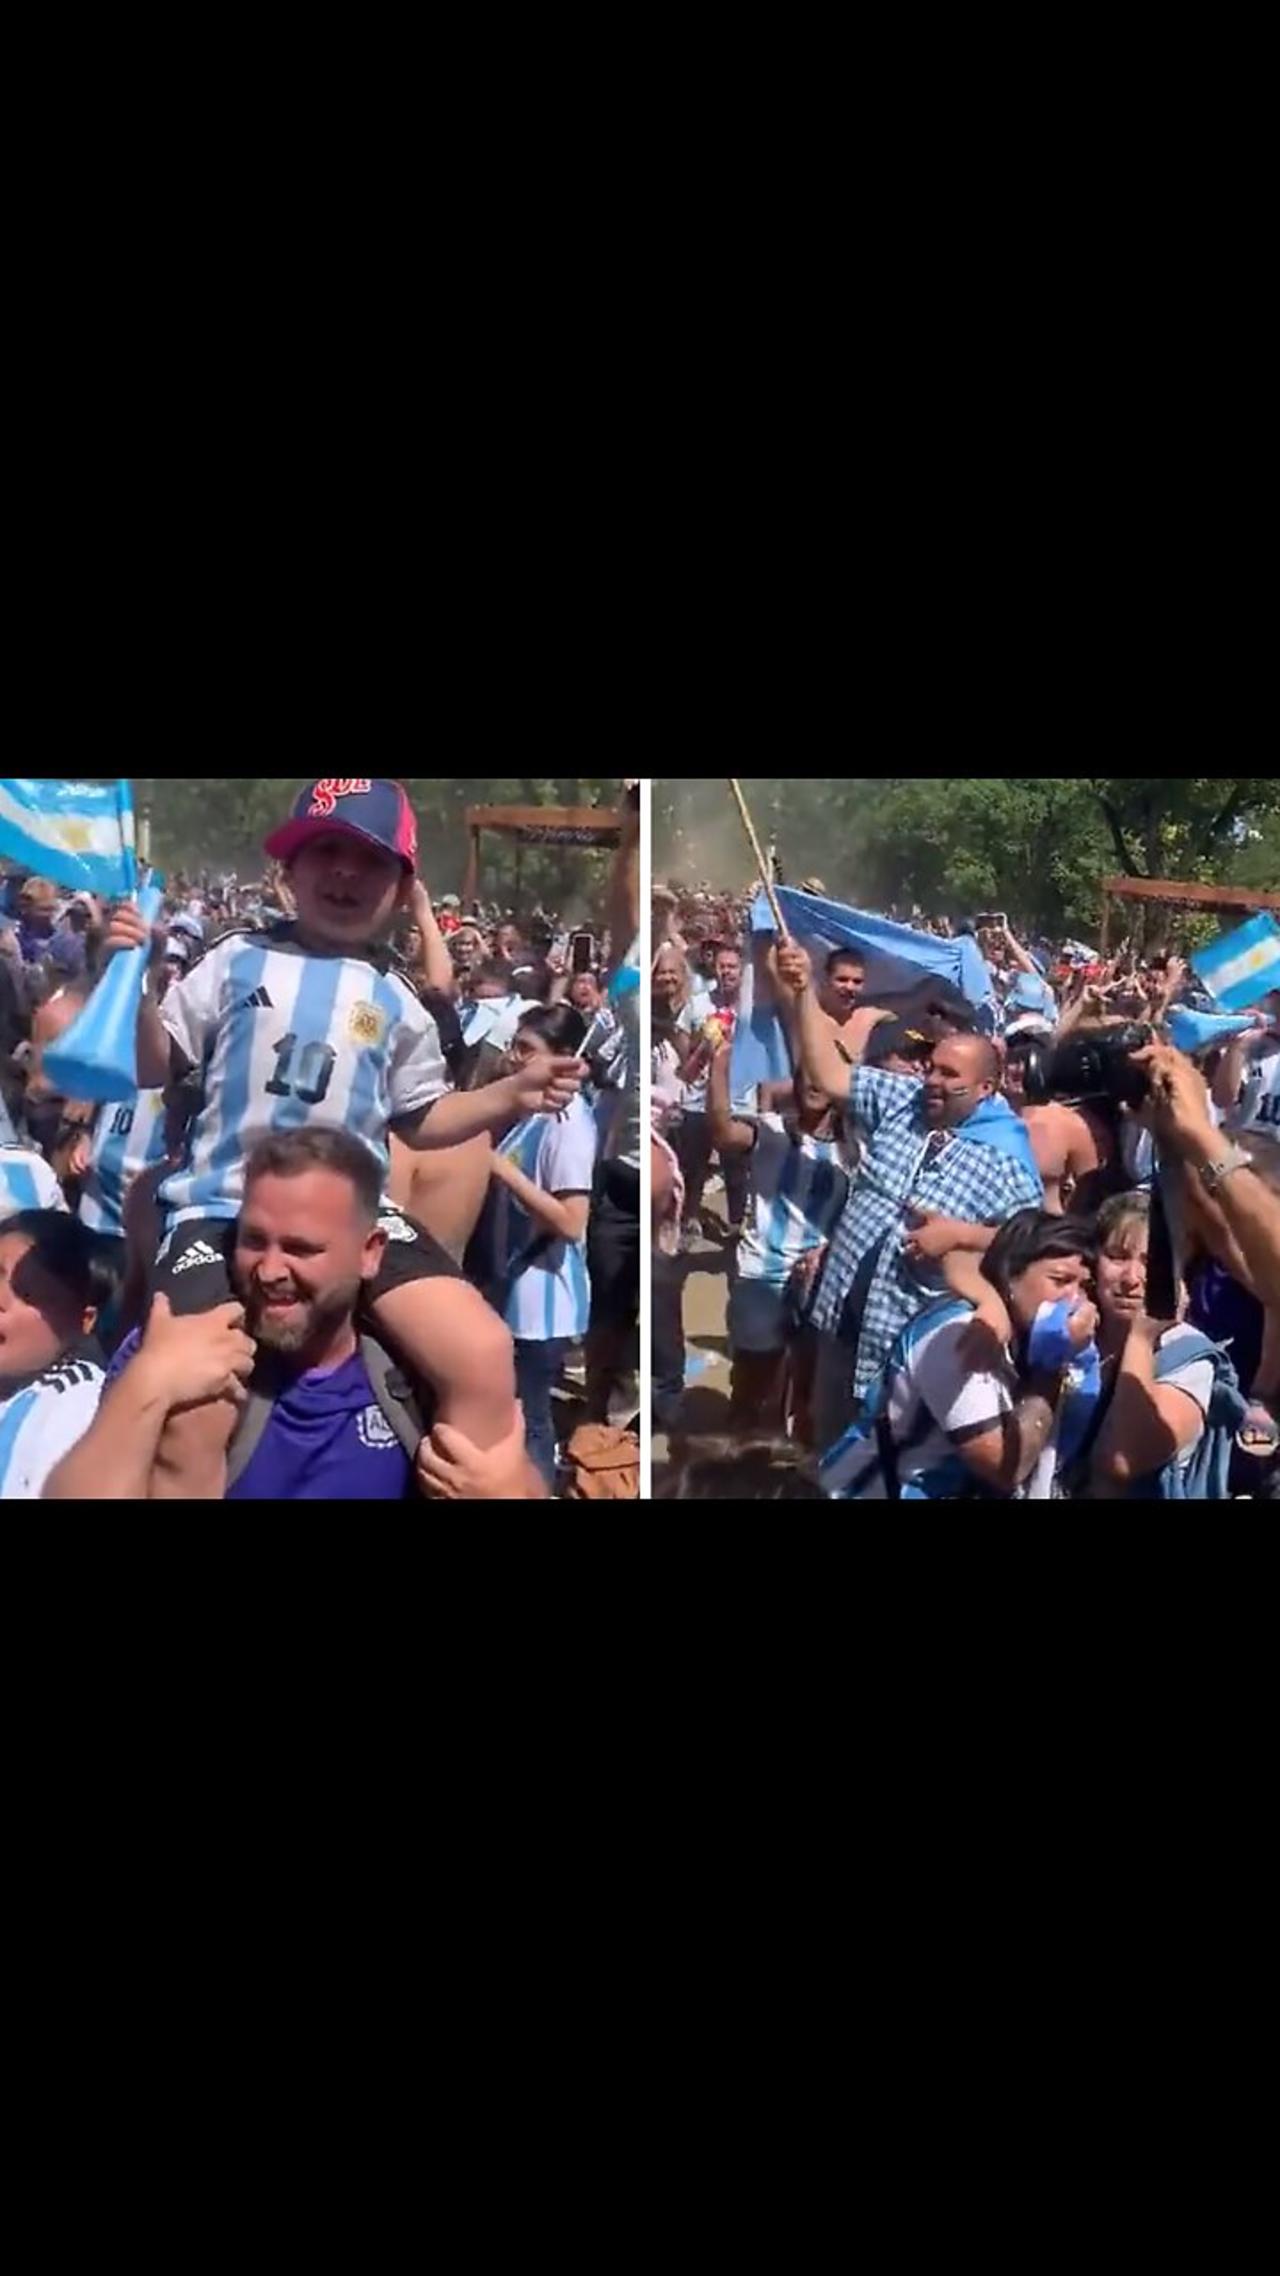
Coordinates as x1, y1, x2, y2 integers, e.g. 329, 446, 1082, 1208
651, 879, 1280, 1500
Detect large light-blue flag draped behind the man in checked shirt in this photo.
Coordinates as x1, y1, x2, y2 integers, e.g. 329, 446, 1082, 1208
731, 885, 991, 1099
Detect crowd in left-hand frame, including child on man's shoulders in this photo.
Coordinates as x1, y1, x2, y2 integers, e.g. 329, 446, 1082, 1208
0, 778, 642, 1500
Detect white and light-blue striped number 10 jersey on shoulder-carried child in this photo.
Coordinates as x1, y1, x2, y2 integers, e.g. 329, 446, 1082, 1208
159, 926, 449, 1231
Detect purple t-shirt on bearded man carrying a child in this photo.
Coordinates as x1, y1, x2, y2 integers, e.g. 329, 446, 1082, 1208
107, 1331, 412, 1502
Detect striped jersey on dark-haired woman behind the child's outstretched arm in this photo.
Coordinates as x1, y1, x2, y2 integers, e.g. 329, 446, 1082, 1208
497, 1097, 597, 1343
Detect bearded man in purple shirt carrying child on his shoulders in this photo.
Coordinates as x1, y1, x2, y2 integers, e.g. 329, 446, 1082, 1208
46, 1129, 542, 1502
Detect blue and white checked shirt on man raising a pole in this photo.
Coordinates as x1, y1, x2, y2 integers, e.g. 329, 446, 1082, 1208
809, 1067, 1045, 1397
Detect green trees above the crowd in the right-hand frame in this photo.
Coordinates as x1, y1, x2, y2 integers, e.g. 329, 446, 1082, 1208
654, 776, 1280, 938
